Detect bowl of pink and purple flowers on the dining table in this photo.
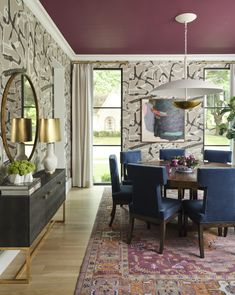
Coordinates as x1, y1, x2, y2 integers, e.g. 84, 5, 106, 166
170, 155, 199, 173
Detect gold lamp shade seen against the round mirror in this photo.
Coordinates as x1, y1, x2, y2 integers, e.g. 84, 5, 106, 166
11, 118, 32, 142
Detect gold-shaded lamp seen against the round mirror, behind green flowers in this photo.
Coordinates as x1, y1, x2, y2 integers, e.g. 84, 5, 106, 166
11, 118, 32, 160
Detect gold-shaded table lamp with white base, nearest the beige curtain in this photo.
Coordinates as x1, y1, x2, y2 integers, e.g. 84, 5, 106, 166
39, 118, 61, 174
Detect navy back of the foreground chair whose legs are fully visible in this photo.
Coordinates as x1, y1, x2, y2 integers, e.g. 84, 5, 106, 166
127, 164, 167, 216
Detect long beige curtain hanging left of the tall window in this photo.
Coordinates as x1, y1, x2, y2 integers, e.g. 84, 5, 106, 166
72, 64, 93, 187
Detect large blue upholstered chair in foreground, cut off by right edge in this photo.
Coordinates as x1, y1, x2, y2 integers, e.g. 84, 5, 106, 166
183, 168, 235, 258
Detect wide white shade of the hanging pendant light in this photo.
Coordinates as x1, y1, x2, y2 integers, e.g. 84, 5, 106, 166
152, 79, 222, 99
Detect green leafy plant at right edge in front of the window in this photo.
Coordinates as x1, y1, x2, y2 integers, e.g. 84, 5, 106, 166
219, 96, 235, 163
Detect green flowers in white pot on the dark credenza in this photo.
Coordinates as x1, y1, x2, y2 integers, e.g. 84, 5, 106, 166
7, 160, 35, 184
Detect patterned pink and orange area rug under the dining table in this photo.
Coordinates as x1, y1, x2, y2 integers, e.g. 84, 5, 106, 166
75, 188, 235, 295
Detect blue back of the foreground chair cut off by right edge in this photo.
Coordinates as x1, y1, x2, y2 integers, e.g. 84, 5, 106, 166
197, 168, 235, 222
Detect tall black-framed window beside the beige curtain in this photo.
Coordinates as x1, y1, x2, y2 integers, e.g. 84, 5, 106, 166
93, 69, 122, 184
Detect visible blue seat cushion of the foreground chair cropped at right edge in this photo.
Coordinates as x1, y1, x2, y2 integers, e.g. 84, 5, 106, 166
183, 200, 205, 222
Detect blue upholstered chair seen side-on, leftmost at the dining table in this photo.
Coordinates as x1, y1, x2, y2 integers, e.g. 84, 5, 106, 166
109, 155, 132, 226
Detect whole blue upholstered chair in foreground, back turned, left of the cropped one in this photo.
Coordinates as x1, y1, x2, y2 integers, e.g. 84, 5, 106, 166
127, 164, 181, 253
